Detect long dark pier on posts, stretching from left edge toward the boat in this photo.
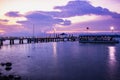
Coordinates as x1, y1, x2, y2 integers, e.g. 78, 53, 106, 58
0, 36, 78, 46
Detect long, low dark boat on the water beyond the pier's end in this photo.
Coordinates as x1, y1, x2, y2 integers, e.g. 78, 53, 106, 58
78, 34, 119, 43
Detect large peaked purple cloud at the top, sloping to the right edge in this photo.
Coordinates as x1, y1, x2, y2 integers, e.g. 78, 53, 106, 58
51, 0, 120, 18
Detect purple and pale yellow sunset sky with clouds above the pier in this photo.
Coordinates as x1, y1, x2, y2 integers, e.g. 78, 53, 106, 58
0, 0, 120, 36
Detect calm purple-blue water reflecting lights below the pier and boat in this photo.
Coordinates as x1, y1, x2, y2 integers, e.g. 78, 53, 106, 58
0, 42, 120, 80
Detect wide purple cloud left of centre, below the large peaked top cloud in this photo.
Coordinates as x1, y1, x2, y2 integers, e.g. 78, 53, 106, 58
17, 11, 71, 27
